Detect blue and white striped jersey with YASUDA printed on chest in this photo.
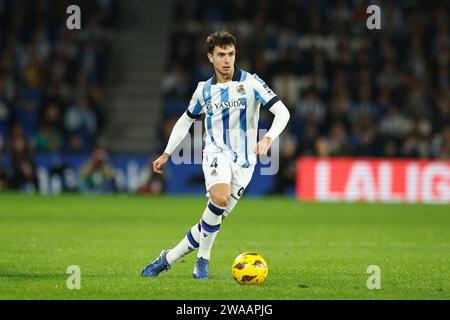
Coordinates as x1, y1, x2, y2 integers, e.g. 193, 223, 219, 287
186, 68, 280, 168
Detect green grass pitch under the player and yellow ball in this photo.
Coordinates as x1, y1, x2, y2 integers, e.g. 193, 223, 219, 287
0, 194, 450, 300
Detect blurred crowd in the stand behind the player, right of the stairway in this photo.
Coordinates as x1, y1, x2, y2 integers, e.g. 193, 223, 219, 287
163, 0, 450, 170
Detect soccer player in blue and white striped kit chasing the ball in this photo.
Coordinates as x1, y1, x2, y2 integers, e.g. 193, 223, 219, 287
142, 31, 290, 279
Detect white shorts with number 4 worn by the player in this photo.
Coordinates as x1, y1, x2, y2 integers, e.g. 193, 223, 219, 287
202, 152, 255, 200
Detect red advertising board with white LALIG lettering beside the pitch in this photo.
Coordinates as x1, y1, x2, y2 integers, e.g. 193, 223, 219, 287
296, 157, 450, 204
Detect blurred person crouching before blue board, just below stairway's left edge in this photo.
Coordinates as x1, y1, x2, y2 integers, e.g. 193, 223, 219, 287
80, 148, 116, 193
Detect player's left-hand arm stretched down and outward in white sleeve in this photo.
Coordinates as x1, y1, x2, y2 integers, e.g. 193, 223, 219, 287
153, 84, 203, 174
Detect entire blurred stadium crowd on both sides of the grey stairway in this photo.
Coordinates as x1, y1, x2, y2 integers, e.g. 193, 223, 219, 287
0, 0, 450, 192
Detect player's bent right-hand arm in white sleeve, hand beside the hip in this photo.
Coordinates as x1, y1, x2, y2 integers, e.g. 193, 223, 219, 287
252, 75, 290, 155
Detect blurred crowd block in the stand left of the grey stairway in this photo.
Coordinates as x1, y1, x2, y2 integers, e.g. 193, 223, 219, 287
0, 0, 116, 190
